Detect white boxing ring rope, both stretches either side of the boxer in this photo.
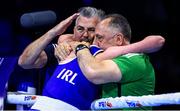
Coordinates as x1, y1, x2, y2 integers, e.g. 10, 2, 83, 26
7, 92, 180, 110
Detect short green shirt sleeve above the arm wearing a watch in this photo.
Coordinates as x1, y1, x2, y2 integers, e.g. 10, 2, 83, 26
113, 53, 144, 83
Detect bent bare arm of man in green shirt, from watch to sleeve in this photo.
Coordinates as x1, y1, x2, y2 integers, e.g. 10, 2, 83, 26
77, 49, 121, 84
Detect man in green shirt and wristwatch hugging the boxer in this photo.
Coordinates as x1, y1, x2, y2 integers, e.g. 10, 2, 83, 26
74, 14, 155, 110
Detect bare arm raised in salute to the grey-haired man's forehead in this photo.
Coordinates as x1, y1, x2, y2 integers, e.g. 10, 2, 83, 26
18, 14, 78, 68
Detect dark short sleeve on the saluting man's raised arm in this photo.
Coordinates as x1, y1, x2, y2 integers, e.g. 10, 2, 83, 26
44, 44, 58, 66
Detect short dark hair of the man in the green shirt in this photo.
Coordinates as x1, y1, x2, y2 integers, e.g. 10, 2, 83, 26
105, 14, 131, 41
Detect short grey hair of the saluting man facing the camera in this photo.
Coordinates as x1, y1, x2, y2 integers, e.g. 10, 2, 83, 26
76, 7, 105, 24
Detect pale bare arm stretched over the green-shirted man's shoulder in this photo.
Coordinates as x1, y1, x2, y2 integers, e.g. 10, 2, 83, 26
96, 36, 165, 60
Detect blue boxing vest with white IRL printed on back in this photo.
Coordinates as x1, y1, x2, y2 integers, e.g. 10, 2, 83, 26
43, 45, 102, 110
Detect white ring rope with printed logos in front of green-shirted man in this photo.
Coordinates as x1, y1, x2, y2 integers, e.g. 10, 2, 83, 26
91, 92, 180, 110
